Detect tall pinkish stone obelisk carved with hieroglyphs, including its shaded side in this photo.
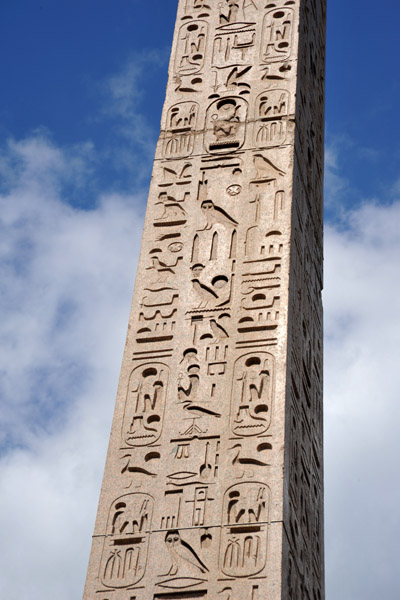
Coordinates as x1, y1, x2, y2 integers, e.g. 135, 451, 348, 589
84, 0, 325, 600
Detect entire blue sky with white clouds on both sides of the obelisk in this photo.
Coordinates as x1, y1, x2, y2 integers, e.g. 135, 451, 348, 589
0, 0, 400, 600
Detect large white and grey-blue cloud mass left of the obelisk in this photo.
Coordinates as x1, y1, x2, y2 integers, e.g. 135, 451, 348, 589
0, 135, 144, 600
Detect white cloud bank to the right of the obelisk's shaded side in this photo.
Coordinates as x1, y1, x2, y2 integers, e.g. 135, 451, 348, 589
324, 202, 400, 600
